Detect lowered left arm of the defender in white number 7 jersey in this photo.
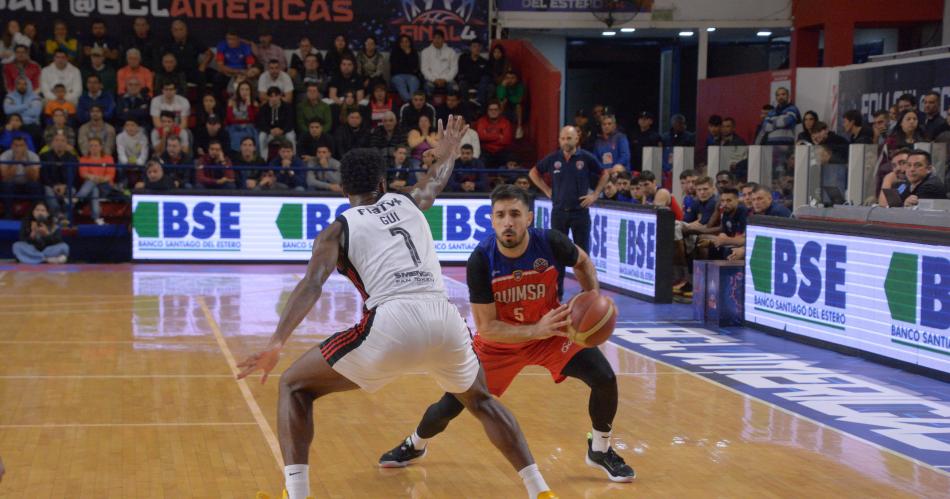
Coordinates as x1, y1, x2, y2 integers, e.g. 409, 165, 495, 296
238, 222, 344, 383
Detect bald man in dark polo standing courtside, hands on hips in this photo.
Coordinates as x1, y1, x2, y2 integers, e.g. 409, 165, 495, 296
529, 126, 608, 251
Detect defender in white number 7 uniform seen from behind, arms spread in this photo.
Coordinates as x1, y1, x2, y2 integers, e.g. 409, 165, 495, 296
238, 116, 566, 499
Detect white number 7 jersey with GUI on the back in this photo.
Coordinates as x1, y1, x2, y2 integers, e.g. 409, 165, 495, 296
339, 193, 446, 309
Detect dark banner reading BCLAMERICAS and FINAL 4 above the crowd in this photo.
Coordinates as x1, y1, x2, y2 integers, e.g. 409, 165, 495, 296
0, 0, 488, 50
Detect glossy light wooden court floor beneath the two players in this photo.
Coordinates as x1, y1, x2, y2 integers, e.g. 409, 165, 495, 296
0, 266, 950, 499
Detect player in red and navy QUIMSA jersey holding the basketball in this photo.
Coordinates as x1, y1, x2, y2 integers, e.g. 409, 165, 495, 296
379, 185, 635, 482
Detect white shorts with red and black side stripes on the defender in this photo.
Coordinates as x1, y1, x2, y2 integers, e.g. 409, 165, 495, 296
320, 298, 479, 393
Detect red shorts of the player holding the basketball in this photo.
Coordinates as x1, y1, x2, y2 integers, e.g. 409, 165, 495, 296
474, 335, 584, 397
